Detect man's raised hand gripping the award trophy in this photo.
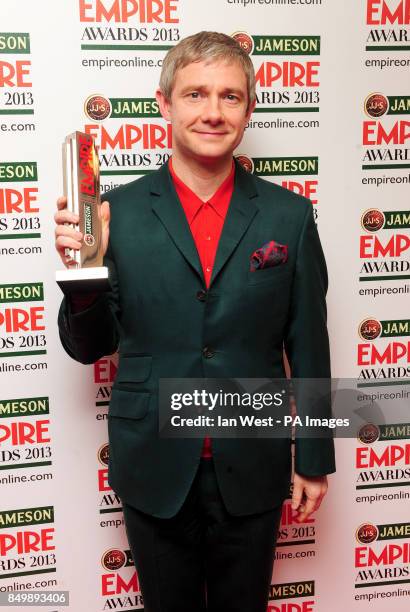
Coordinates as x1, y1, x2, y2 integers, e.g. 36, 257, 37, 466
54, 197, 110, 268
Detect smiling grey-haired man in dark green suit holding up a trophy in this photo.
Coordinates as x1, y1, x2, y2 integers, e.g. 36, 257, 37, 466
55, 32, 335, 612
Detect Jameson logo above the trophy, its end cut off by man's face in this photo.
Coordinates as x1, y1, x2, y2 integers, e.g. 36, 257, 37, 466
84, 95, 161, 121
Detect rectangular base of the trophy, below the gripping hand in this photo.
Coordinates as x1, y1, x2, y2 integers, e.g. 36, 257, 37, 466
56, 266, 111, 293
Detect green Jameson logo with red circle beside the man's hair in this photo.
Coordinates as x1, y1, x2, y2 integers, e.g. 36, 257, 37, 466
232, 32, 320, 55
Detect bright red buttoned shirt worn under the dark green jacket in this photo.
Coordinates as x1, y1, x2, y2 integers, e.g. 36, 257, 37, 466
168, 159, 235, 458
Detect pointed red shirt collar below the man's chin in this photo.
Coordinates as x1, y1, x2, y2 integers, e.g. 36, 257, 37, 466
168, 157, 235, 225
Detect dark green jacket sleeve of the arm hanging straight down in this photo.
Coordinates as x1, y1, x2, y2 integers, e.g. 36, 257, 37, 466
284, 202, 336, 476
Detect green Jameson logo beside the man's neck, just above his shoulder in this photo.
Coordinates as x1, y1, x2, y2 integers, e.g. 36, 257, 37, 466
237, 155, 319, 176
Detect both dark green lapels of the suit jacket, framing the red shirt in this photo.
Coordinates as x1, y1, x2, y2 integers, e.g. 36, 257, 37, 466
151, 161, 259, 286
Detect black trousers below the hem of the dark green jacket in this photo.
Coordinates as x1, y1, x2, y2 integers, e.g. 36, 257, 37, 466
123, 459, 282, 612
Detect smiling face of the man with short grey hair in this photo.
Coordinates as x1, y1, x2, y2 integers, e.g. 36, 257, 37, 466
157, 61, 254, 162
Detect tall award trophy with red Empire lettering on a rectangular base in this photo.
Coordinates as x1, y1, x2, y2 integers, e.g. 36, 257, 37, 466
56, 132, 110, 293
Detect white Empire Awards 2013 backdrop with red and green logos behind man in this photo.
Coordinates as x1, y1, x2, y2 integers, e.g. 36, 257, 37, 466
0, 0, 410, 612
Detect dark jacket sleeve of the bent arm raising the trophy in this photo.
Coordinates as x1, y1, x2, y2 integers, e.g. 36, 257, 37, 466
58, 238, 121, 363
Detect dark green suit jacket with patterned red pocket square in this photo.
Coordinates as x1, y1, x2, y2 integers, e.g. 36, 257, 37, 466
59, 158, 335, 518
